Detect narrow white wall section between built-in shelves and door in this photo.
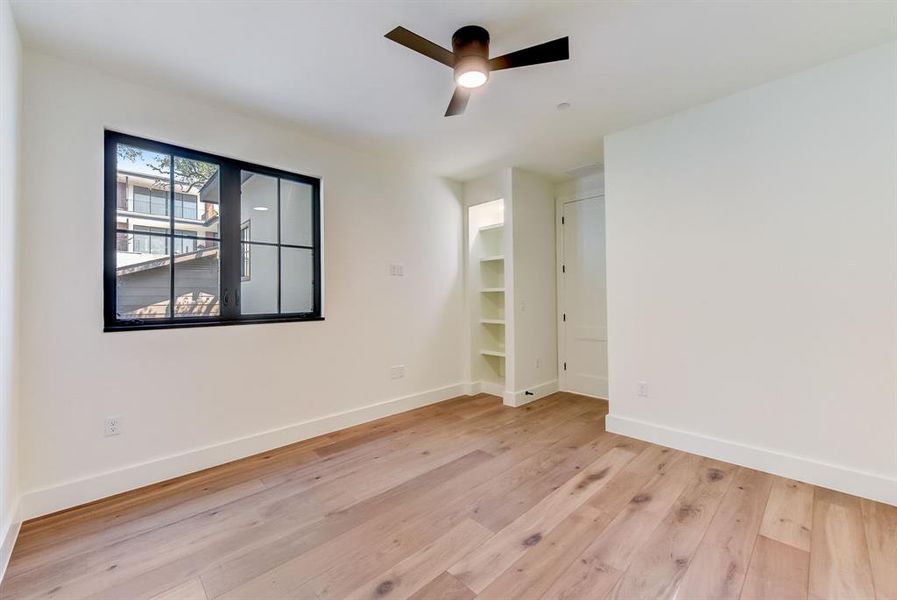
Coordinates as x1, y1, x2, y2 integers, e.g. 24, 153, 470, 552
506, 169, 558, 403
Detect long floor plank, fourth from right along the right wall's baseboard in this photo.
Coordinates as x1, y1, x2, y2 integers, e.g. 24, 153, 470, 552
679, 468, 773, 599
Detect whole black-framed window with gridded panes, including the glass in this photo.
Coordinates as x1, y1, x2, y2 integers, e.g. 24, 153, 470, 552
104, 131, 322, 331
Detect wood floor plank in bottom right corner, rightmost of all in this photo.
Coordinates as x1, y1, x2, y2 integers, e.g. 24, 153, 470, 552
861, 500, 897, 600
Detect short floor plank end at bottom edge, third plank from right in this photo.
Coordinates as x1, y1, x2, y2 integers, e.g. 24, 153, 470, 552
741, 535, 810, 600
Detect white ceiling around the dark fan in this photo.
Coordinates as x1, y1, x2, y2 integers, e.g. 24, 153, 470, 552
13, 0, 897, 179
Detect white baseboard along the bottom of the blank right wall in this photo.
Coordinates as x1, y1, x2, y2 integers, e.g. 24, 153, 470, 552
606, 414, 897, 506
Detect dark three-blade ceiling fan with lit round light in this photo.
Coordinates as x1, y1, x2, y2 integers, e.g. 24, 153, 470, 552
386, 25, 570, 117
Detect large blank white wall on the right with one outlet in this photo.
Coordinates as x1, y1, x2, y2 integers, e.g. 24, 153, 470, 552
605, 43, 897, 504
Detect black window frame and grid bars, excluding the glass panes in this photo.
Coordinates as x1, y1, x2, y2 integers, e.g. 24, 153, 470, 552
103, 129, 324, 332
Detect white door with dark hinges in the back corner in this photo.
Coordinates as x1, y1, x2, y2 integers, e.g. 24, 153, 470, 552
560, 196, 607, 398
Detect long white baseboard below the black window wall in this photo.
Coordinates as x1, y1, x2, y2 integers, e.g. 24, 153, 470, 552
20, 383, 468, 520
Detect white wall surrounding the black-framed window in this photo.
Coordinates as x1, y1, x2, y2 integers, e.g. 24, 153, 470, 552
17, 52, 466, 516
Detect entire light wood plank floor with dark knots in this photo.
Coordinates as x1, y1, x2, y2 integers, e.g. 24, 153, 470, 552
0, 394, 897, 600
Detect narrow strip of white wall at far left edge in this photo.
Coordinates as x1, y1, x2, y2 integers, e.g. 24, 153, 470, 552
0, 0, 22, 579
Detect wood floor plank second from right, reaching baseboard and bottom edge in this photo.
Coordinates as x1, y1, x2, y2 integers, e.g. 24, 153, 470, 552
809, 488, 875, 599
